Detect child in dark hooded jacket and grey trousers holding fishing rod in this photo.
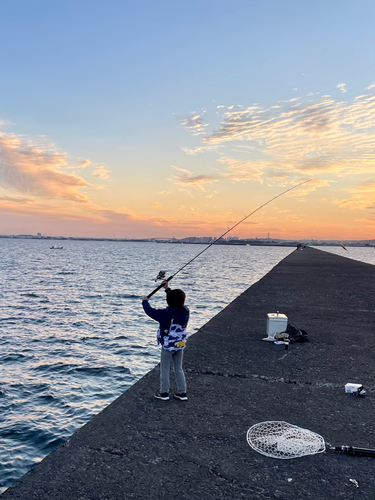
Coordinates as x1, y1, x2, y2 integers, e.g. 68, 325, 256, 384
142, 280, 190, 401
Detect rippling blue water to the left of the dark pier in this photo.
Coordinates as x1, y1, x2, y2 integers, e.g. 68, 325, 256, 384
0, 239, 294, 492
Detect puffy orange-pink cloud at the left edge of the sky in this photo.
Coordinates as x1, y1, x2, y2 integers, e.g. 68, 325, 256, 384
0, 133, 90, 202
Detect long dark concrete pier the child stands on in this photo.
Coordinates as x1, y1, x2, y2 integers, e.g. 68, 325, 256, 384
1, 248, 375, 500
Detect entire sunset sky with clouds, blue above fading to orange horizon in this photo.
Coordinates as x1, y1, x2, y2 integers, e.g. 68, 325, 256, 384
0, 0, 375, 240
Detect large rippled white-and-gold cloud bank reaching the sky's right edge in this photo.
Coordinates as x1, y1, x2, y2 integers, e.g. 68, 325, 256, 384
172, 84, 375, 217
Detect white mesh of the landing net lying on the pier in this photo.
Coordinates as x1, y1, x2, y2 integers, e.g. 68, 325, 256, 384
247, 421, 325, 459
